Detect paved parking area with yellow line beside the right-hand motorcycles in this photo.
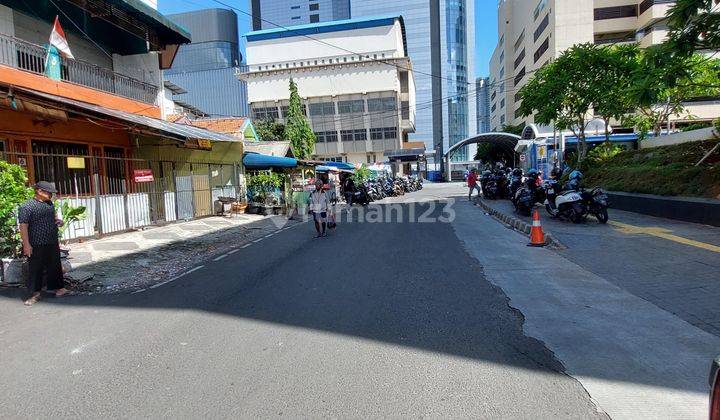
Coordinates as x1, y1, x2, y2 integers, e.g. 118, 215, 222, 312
478, 200, 720, 336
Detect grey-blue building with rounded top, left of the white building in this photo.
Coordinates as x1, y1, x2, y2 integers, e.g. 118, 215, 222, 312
165, 9, 248, 117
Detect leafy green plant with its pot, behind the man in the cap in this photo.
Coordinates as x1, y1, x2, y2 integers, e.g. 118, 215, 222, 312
0, 160, 33, 283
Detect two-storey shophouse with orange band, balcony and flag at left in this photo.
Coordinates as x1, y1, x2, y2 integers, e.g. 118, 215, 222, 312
0, 0, 248, 239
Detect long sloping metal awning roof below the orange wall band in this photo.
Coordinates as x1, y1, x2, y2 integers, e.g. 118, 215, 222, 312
15, 88, 239, 142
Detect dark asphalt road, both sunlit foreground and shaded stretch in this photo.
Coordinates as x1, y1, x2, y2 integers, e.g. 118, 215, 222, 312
0, 190, 605, 418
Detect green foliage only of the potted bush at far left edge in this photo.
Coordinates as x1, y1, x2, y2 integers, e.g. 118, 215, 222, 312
0, 160, 33, 257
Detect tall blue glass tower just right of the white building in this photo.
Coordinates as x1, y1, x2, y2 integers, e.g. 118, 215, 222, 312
350, 0, 476, 165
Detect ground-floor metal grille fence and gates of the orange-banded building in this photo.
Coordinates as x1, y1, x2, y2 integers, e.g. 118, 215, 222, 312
0, 152, 244, 239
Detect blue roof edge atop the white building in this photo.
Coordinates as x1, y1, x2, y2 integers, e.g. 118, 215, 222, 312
245, 14, 407, 56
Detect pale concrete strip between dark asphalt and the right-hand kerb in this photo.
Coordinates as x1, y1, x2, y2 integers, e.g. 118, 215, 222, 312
453, 192, 720, 419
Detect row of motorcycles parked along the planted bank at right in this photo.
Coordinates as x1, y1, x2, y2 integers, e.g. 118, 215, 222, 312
480, 168, 609, 223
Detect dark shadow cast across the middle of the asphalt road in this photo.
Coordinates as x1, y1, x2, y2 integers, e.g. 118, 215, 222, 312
0, 197, 699, 398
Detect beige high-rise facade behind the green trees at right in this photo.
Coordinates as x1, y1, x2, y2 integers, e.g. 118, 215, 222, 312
490, 0, 720, 131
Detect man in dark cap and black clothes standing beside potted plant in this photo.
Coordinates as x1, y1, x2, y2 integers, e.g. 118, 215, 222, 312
18, 181, 69, 306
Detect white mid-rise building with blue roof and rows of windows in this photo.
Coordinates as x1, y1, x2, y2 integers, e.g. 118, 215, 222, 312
238, 16, 416, 163
